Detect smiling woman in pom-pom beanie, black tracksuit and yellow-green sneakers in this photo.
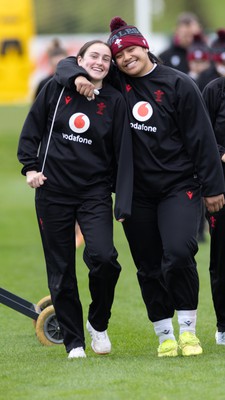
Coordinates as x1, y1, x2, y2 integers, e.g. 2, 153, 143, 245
56, 17, 224, 357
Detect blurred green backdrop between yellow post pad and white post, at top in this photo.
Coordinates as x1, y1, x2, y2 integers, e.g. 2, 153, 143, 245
34, 0, 134, 34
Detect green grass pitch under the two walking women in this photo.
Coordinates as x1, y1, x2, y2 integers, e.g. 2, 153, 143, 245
0, 106, 225, 400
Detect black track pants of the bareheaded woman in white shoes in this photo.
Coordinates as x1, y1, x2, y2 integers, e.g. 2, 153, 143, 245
36, 189, 121, 352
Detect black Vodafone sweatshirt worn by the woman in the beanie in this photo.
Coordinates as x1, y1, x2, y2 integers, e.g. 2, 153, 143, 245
55, 57, 225, 197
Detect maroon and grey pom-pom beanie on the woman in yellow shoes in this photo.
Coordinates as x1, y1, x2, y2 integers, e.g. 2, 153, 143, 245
108, 17, 149, 57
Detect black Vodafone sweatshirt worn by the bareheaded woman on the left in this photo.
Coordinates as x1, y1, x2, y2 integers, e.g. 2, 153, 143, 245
18, 80, 133, 219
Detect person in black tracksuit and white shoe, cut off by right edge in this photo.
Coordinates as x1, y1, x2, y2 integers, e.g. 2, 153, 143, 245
203, 77, 225, 345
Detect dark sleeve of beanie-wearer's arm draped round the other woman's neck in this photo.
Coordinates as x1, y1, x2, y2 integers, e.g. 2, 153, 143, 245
54, 56, 88, 88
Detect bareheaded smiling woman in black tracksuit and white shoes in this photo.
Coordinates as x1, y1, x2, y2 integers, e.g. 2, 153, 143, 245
18, 41, 133, 358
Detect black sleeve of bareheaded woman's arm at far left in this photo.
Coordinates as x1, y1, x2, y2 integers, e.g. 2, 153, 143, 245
17, 80, 56, 175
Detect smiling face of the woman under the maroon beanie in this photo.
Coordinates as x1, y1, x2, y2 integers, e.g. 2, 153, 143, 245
115, 46, 153, 77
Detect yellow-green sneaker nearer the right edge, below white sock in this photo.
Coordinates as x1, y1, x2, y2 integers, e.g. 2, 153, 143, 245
179, 332, 203, 356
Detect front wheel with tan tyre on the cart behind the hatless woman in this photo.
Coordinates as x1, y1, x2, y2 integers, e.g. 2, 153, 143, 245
36, 305, 63, 346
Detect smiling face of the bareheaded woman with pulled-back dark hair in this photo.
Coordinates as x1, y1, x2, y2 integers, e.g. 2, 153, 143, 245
77, 43, 112, 87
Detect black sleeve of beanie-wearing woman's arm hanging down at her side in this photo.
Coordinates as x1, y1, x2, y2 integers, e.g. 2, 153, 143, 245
176, 76, 225, 197
